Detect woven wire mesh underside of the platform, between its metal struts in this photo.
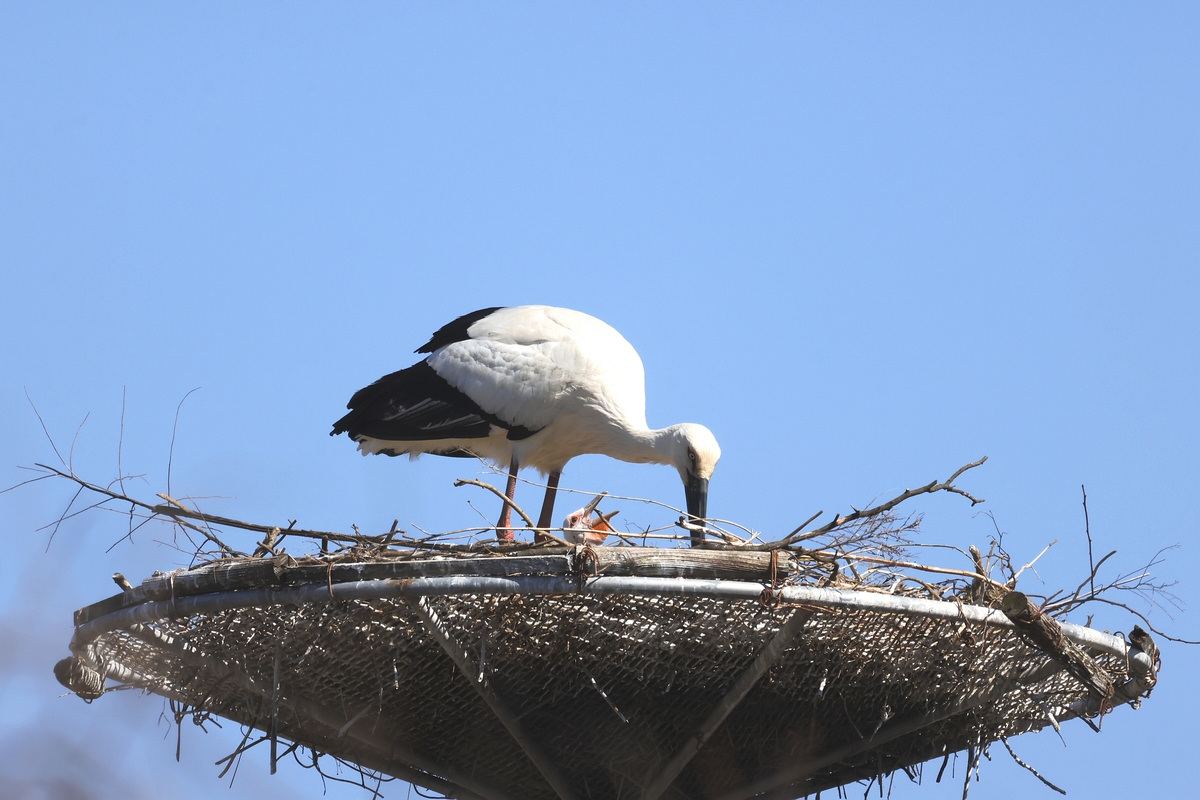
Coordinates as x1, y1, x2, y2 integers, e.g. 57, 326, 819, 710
60, 554, 1147, 800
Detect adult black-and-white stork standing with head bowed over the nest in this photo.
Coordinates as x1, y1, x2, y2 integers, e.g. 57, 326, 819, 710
330, 306, 721, 545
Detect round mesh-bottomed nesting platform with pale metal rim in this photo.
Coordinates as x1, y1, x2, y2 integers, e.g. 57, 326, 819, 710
56, 547, 1156, 800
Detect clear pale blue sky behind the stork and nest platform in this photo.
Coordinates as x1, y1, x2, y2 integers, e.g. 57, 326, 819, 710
0, 2, 1200, 800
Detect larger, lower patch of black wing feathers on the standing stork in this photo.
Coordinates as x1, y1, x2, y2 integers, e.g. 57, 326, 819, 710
329, 361, 533, 441
